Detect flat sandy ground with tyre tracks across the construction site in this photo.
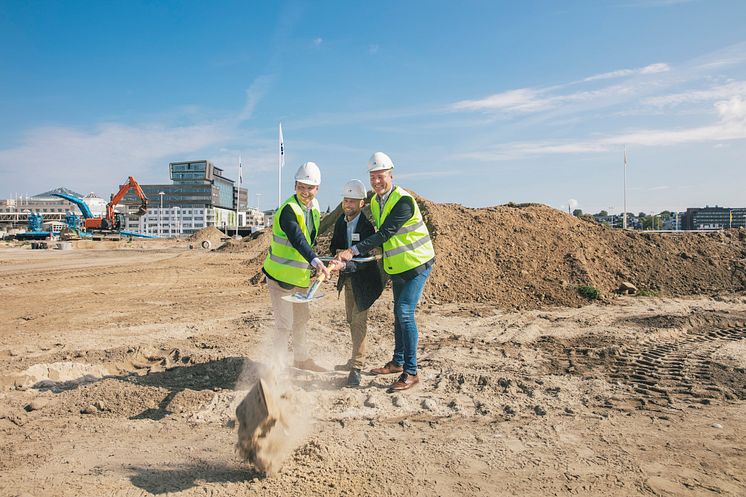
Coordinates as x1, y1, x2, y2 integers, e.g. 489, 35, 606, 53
0, 244, 746, 497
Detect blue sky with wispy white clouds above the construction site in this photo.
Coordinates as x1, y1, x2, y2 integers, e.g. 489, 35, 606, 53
0, 0, 746, 212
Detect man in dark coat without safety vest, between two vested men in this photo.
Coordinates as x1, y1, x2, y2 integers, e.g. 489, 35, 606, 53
330, 180, 383, 387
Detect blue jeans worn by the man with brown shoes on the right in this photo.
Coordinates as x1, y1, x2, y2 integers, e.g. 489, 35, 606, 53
391, 266, 433, 374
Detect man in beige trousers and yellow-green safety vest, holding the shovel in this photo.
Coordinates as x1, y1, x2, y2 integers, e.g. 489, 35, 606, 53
263, 162, 330, 372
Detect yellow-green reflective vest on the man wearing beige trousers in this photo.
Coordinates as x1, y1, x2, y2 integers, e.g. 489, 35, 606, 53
264, 195, 321, 288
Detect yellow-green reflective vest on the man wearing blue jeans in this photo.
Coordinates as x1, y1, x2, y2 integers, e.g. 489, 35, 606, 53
370, 186, 435, 274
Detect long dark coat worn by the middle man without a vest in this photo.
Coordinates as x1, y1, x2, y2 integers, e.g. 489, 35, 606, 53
330, 212, 383, 311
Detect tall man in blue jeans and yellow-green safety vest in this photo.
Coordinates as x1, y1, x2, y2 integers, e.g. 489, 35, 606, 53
333, 152, 435, 392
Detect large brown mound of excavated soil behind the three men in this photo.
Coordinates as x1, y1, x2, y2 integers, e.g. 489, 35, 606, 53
237, 196, 746, 309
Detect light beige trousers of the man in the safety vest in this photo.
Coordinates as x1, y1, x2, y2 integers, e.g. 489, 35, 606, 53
267, 278, 309, 361
